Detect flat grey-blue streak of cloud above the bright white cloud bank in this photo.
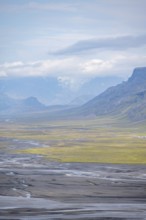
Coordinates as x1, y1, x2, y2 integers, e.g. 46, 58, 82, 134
54, 35, 146, 55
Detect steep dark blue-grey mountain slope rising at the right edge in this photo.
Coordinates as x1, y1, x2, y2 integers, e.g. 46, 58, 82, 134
78, 67, 146, 120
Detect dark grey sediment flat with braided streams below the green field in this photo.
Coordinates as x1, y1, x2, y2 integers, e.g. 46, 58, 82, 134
0, 155, 146, 220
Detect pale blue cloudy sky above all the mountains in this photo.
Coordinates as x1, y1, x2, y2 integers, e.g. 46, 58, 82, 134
0, 0, 146, 81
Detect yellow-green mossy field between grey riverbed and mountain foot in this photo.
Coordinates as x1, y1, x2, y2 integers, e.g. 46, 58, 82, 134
0, 118, 146, 164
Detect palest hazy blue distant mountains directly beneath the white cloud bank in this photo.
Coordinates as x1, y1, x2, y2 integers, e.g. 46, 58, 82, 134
0, 77, 122, 105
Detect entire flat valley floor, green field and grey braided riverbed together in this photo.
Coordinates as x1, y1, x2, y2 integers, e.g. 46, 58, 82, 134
0, 117, 146, 220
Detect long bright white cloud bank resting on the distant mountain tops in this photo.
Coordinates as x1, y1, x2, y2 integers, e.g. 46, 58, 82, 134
0, 52, 146, 79
